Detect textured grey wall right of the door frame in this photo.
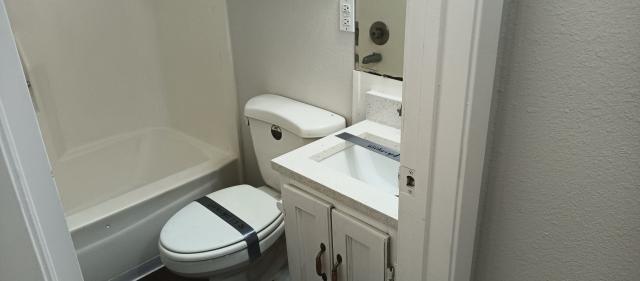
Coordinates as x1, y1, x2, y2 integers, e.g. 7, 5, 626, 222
475, 0, 640, 281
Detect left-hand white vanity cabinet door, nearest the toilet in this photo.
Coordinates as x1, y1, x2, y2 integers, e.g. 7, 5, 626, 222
282, 184, 332, 281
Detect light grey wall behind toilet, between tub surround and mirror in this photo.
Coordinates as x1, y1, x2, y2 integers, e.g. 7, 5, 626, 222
229, 0, 354, 184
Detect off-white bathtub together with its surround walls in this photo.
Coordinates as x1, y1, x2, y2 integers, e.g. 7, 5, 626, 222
4, 0, 240, 281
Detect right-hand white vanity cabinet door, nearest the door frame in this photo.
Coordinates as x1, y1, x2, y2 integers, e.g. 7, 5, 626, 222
331, 210, 389, 281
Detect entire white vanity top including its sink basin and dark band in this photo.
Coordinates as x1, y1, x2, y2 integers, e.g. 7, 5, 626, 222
271, 120, 401, 223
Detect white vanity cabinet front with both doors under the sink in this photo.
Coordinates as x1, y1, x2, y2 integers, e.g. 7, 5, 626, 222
282, 184, 391, 281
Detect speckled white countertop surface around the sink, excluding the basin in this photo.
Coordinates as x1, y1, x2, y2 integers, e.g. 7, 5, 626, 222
271, 120, 400, 227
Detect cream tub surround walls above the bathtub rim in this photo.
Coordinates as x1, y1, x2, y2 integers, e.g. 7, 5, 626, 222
7, 0, 239, 162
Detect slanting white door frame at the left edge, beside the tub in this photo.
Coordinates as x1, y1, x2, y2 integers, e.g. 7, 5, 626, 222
0, 0, 82, 281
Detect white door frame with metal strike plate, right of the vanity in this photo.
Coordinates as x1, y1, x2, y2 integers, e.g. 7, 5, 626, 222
397, 0, 502, 281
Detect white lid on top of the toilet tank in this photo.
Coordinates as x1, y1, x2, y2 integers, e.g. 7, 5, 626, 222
244, 94, 346, 138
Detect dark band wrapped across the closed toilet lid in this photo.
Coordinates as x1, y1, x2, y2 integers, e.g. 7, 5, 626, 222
196, 196, 260, 261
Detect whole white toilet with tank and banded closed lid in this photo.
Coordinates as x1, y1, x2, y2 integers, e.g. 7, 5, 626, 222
158, 94, 346, 281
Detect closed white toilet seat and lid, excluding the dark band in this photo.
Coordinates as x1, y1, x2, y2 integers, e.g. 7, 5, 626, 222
159, 185, 284, 274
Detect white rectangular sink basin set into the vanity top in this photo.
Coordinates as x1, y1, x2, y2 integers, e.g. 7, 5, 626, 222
319, 142, 400, 196
